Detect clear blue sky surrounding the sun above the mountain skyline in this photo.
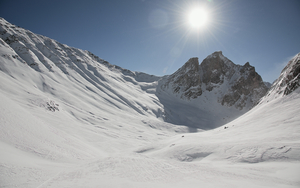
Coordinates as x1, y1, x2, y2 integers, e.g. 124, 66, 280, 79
0, 0, 300, 82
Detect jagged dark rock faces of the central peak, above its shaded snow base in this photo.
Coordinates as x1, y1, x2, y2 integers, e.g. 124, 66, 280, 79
161, 51, 268, 109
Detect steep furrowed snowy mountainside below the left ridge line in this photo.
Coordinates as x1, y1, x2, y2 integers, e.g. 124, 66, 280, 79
0, 19, 162, 120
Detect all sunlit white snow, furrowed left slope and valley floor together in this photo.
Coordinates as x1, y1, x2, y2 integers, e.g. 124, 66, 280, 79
0, 19, 300, 188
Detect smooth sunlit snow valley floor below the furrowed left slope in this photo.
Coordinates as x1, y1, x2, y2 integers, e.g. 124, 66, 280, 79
0, 76, 300, 188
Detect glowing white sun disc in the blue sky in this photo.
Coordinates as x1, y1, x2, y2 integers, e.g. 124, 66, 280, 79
188, 8, 208, 28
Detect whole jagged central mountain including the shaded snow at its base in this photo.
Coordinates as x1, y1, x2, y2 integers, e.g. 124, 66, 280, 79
157, 51, 268, 129
